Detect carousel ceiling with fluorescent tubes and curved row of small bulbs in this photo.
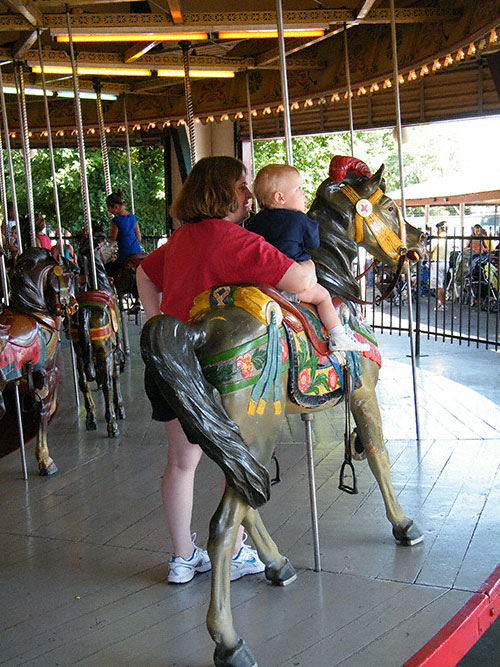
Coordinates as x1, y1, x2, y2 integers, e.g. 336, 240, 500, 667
0, 0, 500, 145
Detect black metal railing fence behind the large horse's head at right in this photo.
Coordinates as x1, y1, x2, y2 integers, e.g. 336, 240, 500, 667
365, 235, 500, 354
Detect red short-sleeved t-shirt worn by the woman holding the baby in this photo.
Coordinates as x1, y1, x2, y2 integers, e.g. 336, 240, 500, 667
141, 219, 293, 322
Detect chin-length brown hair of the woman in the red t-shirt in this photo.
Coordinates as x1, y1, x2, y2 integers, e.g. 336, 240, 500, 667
170, 155, 246, 222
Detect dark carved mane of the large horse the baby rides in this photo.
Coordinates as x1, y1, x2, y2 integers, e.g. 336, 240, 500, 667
307, 168, 367, 300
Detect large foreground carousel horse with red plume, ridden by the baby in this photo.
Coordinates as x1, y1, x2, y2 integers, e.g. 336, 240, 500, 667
141, 158, 424, 667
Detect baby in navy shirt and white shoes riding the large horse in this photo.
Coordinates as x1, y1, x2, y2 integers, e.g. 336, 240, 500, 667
247, 164, 370, 352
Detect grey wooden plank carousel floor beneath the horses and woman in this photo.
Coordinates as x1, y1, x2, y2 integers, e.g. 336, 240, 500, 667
0, 323, 500, 667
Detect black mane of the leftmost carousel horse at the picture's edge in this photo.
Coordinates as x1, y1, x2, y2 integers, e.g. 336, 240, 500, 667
9, 248, 57, 313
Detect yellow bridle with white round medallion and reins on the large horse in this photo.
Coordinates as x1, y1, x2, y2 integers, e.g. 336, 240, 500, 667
337, 183, 408, 305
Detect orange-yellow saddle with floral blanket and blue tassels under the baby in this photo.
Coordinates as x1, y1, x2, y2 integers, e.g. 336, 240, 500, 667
191, 284, 354, 414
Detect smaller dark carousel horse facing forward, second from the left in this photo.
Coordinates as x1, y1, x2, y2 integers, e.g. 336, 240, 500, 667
71, 233, 125, 438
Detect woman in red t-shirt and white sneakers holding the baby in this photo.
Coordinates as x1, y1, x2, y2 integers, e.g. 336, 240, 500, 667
137, 156, 316, 583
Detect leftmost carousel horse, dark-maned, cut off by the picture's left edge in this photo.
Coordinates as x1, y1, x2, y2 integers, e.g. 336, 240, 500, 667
0, 248, 78, 475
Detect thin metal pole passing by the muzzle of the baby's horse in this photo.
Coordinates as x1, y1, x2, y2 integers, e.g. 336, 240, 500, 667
390, 0, 420, 443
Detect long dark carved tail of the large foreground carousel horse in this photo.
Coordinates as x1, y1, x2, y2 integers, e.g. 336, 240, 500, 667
141, 315, 270, 508
